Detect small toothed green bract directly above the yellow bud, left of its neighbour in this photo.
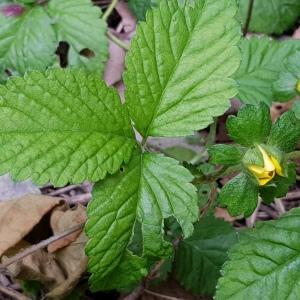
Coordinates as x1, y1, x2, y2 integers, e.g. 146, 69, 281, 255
226, 103, 272, 146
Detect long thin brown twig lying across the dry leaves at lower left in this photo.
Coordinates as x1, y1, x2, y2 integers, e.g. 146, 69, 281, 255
0, 223, 84, 270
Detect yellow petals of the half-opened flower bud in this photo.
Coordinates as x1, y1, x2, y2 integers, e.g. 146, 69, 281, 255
248, 146, 283, 186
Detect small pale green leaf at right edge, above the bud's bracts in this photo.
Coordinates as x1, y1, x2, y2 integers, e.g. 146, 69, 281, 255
273, 51, 300, 101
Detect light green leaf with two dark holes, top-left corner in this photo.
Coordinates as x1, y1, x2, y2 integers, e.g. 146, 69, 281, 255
0, 0, 107, 77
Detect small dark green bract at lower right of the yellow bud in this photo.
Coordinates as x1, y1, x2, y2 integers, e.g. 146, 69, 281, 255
260, 163, 296, 203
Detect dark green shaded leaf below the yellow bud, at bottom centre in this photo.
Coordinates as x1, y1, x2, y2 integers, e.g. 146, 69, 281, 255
175, 216, 237, 295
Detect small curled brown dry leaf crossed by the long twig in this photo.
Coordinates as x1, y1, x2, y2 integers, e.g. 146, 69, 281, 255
48, 204, 87, 252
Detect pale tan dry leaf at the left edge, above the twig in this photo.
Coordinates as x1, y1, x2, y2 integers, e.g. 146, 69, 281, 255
0, 195, 63, 257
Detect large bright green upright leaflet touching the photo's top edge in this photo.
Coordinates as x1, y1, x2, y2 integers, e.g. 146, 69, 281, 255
124, 0, 240, 137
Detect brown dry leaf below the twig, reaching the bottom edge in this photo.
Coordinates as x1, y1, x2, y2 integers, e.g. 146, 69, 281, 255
47, 232, 87, 299
